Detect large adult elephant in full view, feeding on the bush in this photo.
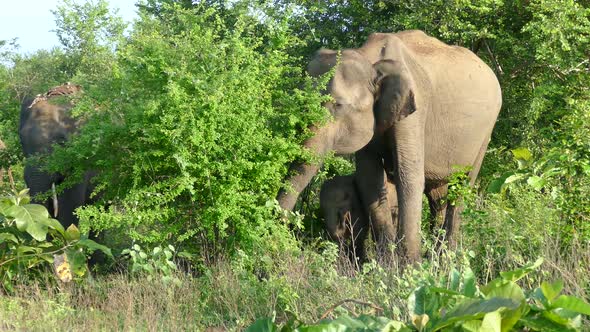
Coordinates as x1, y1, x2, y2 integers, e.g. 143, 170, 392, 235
278, 30, 502, 261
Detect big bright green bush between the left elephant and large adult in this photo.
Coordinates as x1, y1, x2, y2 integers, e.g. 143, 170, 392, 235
45, 4, 326, 262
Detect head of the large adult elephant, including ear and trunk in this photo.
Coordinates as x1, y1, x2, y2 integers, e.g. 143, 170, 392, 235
278, 39, 417, 210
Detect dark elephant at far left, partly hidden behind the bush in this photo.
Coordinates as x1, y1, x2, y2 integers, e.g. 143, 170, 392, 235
19, 84, 94, 228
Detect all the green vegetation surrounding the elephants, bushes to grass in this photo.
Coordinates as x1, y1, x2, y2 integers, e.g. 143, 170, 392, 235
0, 0, 590, 331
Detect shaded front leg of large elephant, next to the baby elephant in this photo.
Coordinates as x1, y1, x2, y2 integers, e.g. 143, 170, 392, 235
355, 145, 396, 261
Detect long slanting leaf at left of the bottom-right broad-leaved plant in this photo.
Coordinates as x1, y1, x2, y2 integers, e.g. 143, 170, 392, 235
433, 297, 520, 331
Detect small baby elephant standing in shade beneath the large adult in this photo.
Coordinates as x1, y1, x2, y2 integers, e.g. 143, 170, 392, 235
320, 175, 398, 265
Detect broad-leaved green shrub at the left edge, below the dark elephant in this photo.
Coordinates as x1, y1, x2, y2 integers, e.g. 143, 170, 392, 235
0, 189, 112, 291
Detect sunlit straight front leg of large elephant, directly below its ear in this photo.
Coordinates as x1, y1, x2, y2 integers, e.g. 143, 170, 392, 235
387, 123, 424, 262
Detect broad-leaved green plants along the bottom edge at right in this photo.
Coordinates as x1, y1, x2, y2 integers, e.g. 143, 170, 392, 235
247, 259, 590, 332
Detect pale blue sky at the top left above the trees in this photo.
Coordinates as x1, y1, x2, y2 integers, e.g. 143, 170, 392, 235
0, 0, 138, 53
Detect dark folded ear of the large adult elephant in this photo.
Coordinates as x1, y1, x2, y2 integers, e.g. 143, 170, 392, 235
373, 60, 416, 128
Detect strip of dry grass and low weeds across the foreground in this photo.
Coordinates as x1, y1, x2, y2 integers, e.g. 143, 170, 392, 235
0, 187, 590, 331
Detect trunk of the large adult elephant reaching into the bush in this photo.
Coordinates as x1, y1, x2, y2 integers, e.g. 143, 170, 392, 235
277, 125, 335, 210
